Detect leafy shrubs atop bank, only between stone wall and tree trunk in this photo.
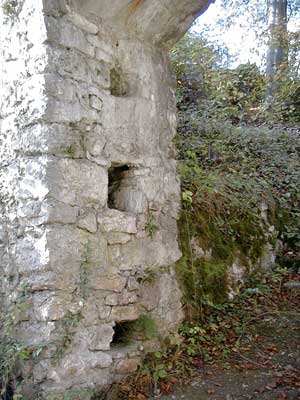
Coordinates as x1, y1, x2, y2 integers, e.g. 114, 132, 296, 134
171, 33, 264, 126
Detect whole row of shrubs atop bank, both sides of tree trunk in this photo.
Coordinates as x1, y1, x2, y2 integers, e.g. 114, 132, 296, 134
171, 33, 300, 126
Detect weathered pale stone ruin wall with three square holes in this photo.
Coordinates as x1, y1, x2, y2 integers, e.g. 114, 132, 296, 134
0, 0, 211, 393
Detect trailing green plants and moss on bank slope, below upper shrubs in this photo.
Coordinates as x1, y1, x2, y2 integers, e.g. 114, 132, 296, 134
176, 123, 300, 317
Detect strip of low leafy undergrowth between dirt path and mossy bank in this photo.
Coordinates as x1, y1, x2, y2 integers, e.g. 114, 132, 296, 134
107, 268, 300, 400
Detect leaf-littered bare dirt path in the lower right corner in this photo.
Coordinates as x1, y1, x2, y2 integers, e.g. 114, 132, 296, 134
159, 309, 300, 400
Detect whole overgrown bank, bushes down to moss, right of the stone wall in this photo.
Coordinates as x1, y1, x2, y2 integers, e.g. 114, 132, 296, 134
172, 35, 300, 314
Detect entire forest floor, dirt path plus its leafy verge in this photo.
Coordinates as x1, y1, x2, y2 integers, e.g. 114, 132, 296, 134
109, 271, 300, 400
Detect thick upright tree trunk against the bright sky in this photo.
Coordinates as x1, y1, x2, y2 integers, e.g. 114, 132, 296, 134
266, 0, 288, 105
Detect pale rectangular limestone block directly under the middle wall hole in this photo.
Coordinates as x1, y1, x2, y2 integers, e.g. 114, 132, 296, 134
98, 210, 137, 233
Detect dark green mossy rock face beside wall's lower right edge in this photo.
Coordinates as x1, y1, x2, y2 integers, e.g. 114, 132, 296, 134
176, 209, 267, 315
